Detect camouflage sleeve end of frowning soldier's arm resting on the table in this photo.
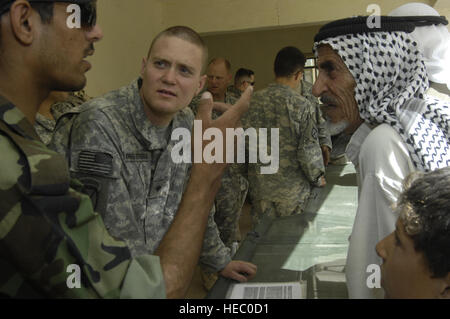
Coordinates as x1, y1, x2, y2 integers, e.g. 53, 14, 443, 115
200, 206, 231, 272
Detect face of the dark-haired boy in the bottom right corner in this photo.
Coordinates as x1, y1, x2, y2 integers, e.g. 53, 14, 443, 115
376, 218, 450, 299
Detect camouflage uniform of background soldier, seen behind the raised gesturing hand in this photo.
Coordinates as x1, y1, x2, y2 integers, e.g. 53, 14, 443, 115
189, 90, 248, 248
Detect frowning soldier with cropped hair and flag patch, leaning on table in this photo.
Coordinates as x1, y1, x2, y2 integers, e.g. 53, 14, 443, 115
50, 28, 251, 280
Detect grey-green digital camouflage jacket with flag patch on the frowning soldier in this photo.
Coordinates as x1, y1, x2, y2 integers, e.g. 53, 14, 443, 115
50, 79, 231, 271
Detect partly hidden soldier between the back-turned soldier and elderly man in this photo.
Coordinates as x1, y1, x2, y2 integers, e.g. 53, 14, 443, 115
300, 81, 332, 166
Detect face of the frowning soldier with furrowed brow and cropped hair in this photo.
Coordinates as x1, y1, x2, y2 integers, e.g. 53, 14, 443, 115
141, 36, 206, 124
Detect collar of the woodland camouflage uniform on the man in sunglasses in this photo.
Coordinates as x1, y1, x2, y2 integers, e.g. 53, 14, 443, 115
0, 96, 39, 140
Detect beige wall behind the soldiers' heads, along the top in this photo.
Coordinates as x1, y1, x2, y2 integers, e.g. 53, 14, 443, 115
86, 0, 450, 96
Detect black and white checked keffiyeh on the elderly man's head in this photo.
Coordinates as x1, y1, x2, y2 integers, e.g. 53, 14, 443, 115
315, 31, 450, 171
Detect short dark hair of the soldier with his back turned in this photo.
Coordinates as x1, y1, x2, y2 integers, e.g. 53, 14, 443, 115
274, 47, 306, 77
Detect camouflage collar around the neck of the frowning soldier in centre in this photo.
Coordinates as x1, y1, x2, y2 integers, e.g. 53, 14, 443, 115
129, 78, 177, 151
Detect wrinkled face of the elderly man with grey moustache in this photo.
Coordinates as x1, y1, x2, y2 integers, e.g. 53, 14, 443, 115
313, 45, 362, 133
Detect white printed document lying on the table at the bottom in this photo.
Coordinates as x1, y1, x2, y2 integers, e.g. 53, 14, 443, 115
227, 281, 306, 299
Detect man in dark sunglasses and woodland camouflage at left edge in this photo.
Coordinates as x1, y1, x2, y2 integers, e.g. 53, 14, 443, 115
0, 1, 165, 298
